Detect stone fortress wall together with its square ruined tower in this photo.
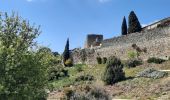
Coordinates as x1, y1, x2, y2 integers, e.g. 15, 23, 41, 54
71, 17, 170, 64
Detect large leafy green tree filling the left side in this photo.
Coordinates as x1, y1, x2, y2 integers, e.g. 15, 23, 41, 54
0, 13, 48, 100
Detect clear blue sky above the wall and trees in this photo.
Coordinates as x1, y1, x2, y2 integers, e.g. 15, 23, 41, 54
0, 0, 170, 53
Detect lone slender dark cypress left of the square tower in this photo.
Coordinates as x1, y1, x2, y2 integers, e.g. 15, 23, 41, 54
63, 38, 70, 66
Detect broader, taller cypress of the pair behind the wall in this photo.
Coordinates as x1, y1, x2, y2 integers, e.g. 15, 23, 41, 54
128, 11, 142, 34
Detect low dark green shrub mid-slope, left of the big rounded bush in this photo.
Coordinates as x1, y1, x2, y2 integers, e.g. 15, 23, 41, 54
75, 74, 94, 82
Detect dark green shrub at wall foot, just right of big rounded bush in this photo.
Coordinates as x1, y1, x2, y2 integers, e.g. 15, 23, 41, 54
126, 59, 142, 68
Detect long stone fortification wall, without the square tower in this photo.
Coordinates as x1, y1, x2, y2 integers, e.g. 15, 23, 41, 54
72, 26, 170, 64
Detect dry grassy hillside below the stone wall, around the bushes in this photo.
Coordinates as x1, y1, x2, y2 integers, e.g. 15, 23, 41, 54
48, 61, 170, 100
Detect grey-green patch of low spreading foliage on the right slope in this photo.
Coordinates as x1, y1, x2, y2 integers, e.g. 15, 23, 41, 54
137, 68, 168, 79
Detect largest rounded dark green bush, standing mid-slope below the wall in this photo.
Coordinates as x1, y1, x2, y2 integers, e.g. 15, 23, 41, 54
102, 57, 125, 85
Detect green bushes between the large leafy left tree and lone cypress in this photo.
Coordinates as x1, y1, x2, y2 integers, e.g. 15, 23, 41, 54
38, 47, 68, 81
